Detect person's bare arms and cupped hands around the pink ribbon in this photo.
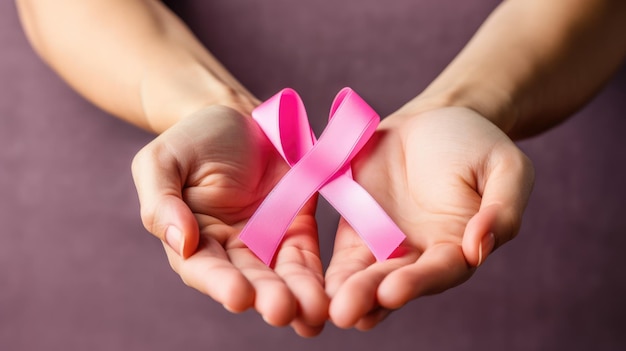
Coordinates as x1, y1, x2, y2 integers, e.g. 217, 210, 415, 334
17, 0, 626, 336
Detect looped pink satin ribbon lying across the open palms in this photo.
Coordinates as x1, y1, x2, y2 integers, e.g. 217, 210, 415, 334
239, 88, 405, 266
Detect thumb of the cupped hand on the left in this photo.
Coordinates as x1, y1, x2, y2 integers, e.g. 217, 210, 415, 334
132, 142, 199, 258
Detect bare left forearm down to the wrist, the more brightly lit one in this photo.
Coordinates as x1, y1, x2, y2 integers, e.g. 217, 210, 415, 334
17, 0, 257, 132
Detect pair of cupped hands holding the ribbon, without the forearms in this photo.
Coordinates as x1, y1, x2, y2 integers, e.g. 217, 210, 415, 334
133, 97, 533, 337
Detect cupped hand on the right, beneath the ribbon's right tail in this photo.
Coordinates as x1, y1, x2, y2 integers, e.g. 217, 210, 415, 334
326, 107, 534, 330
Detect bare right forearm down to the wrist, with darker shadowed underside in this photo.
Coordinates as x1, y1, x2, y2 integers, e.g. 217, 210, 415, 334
405, 0, 626, 138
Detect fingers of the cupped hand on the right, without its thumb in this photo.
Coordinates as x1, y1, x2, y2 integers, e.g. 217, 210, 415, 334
326, 217, 473, 330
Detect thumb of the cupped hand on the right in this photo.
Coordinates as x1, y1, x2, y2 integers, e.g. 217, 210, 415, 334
462, 148, 534, 267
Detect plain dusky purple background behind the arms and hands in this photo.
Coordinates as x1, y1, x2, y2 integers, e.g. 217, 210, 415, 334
0, 0, 626, 351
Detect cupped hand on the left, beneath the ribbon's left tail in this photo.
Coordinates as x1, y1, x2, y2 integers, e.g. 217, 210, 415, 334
132, 107, 329, 336
